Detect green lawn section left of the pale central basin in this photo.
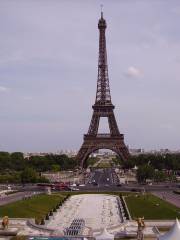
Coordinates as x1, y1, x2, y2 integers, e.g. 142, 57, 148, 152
0, 194, 65, 218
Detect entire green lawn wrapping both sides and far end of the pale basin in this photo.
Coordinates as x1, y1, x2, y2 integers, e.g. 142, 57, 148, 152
0, 192, 177, 219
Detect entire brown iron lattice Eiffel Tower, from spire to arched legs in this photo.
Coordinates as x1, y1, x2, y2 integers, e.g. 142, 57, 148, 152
76, 12, 129, 167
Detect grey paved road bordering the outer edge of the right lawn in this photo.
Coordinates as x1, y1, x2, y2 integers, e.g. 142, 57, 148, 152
153, 191, 180, 208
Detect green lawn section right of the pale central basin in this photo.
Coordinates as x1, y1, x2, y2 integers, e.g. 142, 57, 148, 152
125, 194, 180, 219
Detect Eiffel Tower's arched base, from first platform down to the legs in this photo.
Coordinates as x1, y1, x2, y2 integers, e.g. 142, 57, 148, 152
76, 134, 129, 168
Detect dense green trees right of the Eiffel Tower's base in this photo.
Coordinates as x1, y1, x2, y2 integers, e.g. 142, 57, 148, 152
113, 153, 180, 183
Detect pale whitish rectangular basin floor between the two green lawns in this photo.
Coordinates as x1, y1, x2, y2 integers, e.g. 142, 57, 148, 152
46, 194, 122, 233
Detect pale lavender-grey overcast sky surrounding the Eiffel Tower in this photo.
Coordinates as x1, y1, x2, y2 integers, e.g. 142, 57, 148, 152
0, 0, 180, 152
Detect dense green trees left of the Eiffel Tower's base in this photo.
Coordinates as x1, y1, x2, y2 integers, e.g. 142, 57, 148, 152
0, 152, 77, 183
